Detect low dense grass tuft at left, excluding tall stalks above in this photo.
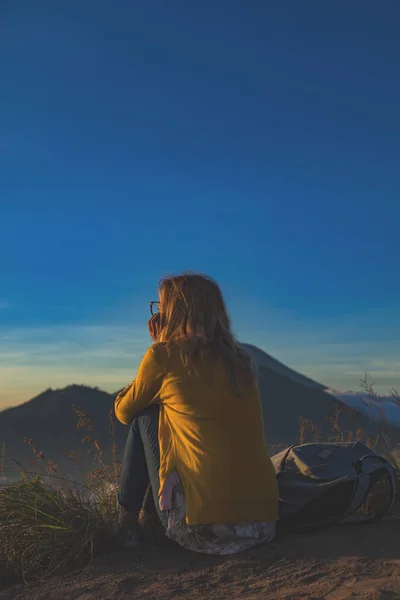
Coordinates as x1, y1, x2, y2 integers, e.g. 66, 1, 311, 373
0, 476, 116, 581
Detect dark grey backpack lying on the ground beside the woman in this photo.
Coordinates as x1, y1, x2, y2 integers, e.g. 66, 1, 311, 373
271, 442, 396, 530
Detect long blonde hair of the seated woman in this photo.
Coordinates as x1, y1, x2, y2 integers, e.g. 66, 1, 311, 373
157, 273, 256, 395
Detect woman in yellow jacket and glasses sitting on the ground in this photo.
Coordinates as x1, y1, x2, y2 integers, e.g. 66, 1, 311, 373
115, 274, 278, 554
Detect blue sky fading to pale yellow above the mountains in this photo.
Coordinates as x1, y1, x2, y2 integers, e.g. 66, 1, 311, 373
0, 0, 400, 408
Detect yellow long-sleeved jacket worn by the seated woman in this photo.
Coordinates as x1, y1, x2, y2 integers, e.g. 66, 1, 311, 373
115, 343, 278, 525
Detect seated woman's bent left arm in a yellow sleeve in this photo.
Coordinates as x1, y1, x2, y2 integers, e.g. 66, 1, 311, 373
114, 344, 167, 425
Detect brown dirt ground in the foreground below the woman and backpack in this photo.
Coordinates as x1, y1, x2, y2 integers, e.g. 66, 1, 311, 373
0, 518, 400, 600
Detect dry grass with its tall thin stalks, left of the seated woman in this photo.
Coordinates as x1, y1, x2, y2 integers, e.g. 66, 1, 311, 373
0, 407, 120, 581
